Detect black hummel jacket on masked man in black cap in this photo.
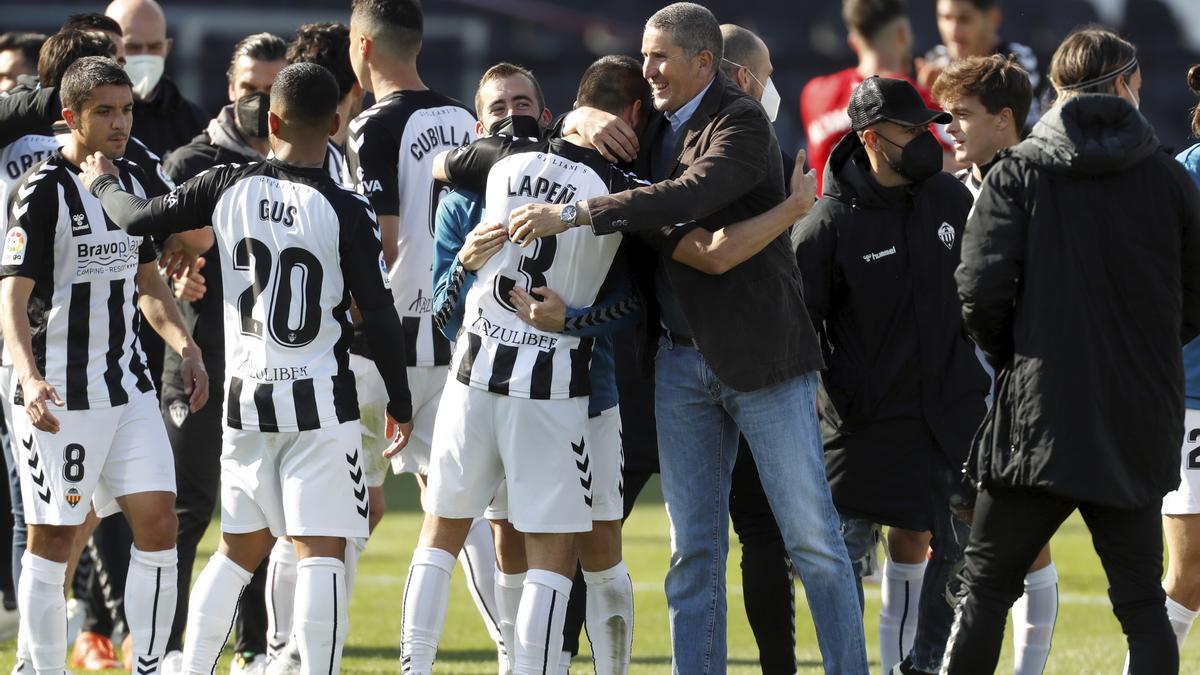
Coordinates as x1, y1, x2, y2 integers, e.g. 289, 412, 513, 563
793, 133, 988, 530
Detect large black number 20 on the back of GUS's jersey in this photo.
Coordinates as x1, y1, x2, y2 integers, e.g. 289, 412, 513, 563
233, 237, 324, 347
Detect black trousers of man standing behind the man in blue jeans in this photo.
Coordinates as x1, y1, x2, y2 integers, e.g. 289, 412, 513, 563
563, 440, 796, 675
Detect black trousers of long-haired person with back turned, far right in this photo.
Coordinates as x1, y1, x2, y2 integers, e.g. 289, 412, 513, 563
942, 489, 1180, 675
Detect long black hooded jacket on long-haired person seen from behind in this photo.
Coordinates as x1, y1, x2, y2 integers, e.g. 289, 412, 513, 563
955, 95, 1200, 508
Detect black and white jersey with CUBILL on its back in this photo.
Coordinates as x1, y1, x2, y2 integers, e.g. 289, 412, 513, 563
347, 90, 475, 366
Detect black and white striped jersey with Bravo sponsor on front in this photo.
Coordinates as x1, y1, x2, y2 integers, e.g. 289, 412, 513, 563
0, 150, 155, 410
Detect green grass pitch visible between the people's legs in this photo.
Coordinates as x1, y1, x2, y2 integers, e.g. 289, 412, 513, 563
0, 477, 1200, 675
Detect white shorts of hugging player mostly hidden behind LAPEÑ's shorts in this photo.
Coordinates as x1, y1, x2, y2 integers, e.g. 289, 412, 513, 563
484, 406, 625, 520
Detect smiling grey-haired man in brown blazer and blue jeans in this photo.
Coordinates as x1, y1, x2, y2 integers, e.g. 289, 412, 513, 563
501, 2, 868, 675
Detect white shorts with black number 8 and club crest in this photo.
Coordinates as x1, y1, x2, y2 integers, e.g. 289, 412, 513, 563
12, 392, 175, 525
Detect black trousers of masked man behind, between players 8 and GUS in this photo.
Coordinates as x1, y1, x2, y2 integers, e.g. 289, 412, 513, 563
162, 386, 266, 653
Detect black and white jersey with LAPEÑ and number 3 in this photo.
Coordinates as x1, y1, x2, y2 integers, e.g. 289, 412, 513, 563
445, 135, 647, 399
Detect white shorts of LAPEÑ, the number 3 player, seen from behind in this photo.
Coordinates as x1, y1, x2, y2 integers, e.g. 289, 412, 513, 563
422, 378, 593, 532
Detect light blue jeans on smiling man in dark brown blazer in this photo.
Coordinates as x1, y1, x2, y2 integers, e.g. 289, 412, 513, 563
654, 340, 868, 675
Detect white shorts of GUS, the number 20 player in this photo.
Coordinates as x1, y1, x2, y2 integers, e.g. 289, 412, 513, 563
221, 422, 370, 539
